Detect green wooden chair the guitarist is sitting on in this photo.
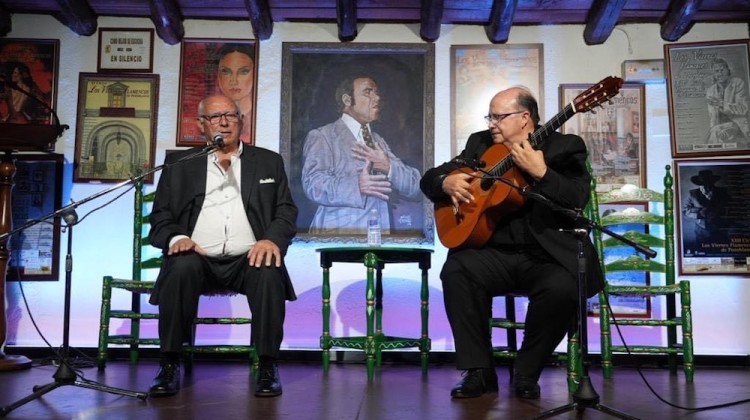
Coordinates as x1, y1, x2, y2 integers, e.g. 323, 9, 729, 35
490, 293, 583, 392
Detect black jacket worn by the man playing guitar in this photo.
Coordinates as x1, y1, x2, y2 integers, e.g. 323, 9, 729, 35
420, 130, 603, 296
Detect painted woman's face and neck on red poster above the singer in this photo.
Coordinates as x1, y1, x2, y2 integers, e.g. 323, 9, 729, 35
216, 44, 255, 143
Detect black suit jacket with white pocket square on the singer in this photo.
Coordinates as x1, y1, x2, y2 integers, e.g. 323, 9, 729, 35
148, 145, 297, 303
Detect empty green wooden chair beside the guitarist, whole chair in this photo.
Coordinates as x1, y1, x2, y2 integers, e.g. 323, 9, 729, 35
589, 165, 694, 382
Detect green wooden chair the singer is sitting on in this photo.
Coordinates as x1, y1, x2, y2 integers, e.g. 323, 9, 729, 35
97, 182, 258, 372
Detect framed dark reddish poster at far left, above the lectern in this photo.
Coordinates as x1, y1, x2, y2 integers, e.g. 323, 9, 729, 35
0, 38, 60, 133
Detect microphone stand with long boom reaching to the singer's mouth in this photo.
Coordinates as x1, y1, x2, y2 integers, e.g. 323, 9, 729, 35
0, 144, 220, 417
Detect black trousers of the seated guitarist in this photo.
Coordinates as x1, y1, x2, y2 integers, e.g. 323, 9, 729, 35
440, 247, 578, 379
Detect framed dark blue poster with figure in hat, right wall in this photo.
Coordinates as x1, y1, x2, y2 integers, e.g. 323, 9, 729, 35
674, 158, 750, 276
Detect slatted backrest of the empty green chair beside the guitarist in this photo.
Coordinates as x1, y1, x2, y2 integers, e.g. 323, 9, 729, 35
588, 165, 675, 285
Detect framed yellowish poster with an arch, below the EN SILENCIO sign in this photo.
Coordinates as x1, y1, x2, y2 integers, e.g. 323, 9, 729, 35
73, 73, 159, 184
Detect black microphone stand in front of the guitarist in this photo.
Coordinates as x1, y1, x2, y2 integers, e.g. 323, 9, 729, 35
521, 189, 656, 420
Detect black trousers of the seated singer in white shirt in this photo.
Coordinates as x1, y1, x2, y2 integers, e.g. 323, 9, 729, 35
158, 253, 286, 358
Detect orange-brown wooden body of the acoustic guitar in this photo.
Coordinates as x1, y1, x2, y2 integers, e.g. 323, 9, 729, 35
435, 144, 528, 249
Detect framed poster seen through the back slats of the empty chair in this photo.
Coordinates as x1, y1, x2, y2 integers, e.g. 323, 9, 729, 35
588, 201, 652, 318
